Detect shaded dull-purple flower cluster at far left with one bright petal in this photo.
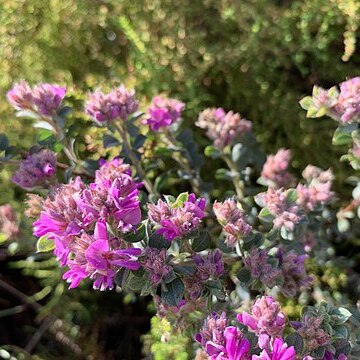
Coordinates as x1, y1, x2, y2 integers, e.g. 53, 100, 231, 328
11, 150, 56, 189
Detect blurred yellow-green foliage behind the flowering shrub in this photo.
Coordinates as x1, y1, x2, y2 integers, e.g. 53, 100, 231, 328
0, 0, 360, 359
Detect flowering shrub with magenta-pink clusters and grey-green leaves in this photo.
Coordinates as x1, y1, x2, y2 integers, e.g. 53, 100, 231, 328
0, 78, 360, 360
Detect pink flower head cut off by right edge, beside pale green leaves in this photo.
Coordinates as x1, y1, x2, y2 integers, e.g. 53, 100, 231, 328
335, 76, 360, 124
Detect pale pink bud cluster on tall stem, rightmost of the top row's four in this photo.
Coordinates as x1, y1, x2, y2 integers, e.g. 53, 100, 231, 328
196, 108, 252, 149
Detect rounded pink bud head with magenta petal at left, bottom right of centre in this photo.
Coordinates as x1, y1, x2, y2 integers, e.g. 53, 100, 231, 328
237, 296, 285, 349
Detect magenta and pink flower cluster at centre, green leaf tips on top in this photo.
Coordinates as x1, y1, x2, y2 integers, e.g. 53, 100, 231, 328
148, 194, 206, 241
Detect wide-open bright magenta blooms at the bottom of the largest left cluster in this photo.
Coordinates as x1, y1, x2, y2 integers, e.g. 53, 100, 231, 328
63, 222, 141, 291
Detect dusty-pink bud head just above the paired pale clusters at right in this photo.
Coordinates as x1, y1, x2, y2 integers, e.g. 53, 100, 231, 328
261, 149, 294, 188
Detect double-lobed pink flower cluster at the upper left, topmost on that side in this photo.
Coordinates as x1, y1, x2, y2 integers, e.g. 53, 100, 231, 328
7, 80, 66, 116
